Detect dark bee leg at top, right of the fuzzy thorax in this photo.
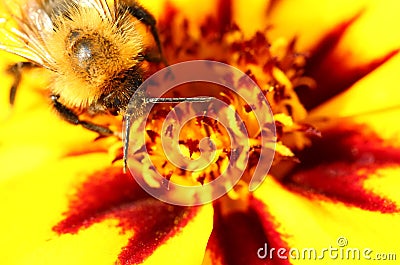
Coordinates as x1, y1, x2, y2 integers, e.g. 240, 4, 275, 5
128, 3, 168, 65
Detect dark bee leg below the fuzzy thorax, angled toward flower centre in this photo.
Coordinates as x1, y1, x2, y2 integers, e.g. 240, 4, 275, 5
50, 95, 114, 136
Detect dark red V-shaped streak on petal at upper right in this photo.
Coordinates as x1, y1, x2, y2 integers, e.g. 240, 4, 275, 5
296, 8, 398, 109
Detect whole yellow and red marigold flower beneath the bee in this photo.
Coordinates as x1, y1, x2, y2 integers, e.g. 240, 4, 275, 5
0, 0, 400, 264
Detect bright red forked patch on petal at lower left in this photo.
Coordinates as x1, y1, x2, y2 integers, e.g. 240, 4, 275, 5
53, 168, 198, 264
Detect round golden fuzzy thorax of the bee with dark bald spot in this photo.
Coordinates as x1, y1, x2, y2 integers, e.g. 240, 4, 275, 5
46, 2, 144, 108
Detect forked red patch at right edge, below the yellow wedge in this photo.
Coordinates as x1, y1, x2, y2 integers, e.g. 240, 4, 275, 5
284, 125, 400, 213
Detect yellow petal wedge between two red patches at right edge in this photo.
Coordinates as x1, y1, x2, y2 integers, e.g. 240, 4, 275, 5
308, 55, 400, 146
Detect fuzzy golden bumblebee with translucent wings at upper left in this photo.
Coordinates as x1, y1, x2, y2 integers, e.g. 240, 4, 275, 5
0, 0, 165, 136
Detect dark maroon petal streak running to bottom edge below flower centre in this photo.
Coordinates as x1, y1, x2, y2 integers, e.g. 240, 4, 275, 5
211, 204, 290, 265
